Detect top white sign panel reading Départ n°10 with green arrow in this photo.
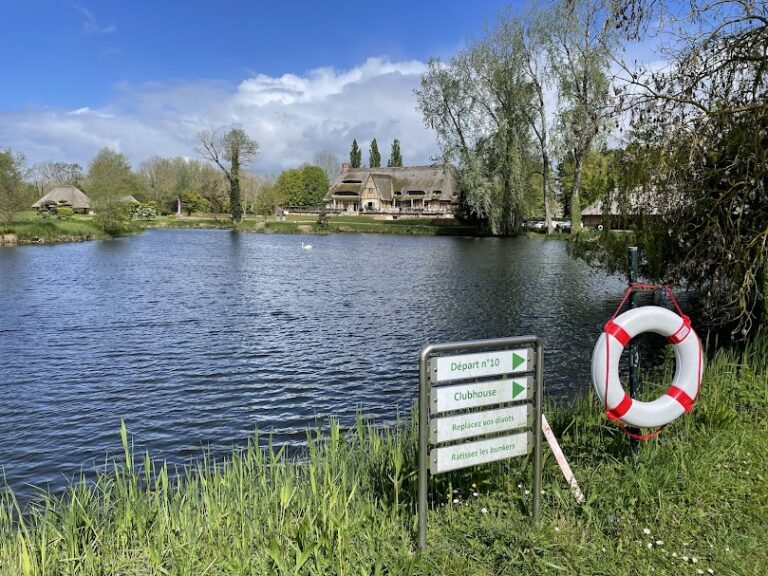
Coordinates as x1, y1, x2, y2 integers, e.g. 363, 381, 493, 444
432, 348, 533, 382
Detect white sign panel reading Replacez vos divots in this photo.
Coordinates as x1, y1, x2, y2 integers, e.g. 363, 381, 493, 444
429, 404, 533, 444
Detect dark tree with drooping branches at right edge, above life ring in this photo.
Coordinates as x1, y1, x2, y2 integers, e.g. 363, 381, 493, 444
617, 0, 768, 338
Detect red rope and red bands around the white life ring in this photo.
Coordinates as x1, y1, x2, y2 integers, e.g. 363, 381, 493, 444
593, 282, 702, 441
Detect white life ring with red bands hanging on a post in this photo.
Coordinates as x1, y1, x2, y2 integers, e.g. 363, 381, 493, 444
592, 306, 704, 428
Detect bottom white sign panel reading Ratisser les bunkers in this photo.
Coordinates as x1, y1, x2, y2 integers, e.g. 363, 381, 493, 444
429, 432, 533, 474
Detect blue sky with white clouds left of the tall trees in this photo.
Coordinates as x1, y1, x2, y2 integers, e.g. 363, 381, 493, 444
0, 0, 520, 173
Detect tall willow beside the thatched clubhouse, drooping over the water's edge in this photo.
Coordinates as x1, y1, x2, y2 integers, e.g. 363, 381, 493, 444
416, 15, 533, 235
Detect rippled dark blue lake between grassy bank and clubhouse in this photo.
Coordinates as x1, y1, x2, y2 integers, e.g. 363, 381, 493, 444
0, 230, 624, 499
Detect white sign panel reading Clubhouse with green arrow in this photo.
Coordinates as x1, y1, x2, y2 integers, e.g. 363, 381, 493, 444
429, 377, 533, 414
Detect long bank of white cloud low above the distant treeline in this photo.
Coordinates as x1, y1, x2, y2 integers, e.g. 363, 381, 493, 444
0, 58, 437, 173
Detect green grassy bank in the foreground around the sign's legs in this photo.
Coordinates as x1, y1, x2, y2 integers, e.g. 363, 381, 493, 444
0, 336, 768, 576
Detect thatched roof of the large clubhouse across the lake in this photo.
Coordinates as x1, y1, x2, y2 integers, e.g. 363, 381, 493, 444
325, 164, 459, 202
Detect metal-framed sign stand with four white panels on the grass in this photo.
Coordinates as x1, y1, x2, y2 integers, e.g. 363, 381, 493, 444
418, 336, 544, 548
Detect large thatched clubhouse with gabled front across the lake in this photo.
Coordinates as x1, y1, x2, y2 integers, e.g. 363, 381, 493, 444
324, 164, 459, 213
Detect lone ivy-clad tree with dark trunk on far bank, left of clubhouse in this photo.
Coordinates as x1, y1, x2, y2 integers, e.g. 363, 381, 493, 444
197, 128, 259, 223
